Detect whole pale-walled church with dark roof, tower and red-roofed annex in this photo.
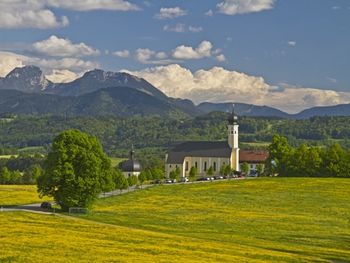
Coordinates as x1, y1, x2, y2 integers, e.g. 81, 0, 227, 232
165, 110, 268, 177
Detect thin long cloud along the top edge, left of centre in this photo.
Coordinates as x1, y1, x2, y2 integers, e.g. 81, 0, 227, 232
46, 0, 140, 11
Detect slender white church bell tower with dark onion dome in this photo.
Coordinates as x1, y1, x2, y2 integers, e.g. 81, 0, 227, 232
227, 105, 239, 171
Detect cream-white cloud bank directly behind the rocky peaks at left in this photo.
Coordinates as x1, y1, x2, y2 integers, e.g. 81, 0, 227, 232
0, 51, 100, 82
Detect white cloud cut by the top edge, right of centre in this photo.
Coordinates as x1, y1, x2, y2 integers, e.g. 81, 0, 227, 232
217, 0, 275, 15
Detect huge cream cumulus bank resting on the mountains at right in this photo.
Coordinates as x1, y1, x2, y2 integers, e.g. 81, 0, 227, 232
126, 64, 350, 113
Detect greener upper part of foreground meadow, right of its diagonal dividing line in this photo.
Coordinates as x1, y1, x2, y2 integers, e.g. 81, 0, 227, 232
80, 178, 350, 262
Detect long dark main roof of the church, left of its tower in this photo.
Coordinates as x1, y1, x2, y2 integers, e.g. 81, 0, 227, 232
167, 141, 231, 163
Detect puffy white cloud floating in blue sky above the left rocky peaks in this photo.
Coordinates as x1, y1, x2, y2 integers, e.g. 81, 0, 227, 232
33, 35, 100, 57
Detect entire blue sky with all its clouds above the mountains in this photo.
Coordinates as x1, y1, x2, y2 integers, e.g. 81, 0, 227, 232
0, 0, 350, 112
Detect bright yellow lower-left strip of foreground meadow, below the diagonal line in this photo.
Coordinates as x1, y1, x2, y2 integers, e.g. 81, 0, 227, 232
0, 212, 293, 263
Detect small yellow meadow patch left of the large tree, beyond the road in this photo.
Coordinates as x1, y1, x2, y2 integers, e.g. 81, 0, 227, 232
0, 185, 51, 207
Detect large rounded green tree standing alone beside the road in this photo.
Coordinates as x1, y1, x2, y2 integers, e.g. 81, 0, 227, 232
38, 130, 114, 210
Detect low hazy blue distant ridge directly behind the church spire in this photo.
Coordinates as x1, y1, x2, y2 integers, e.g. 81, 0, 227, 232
198, 102, 290, 118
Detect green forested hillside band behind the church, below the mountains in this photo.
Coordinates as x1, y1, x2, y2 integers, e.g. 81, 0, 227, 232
0, 112, 350, 156
